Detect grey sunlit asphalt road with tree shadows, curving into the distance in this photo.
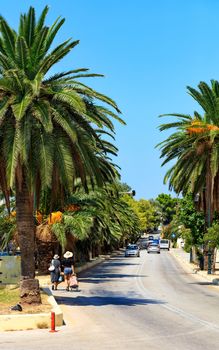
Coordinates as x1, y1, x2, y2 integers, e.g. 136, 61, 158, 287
0, 251, 219, 350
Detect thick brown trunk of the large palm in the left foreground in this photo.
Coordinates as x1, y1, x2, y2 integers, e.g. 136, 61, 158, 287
16, 175, 41, 304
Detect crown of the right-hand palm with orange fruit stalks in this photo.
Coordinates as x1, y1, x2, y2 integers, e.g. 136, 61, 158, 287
158, 80, 219, 226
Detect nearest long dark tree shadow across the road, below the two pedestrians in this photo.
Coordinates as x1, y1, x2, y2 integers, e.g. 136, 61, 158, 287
56, 296, 165, 306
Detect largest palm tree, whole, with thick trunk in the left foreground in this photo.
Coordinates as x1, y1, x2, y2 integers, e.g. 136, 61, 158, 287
0, 7, 123, 302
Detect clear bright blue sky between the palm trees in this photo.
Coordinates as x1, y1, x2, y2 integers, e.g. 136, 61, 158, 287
0, 0, 219, 199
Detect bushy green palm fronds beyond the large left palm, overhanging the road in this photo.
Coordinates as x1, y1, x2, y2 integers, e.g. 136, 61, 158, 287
51, 184, 139, 256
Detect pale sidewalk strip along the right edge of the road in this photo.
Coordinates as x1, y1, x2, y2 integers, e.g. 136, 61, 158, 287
170, 248, 219, 285
